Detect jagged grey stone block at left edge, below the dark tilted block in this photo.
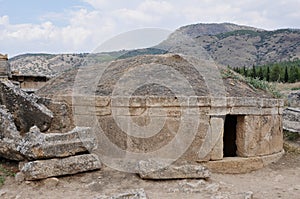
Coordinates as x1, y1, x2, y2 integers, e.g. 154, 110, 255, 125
0, 106, 24, 160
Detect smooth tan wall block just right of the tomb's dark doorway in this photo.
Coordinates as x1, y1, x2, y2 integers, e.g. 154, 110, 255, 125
236, 115, 283, 157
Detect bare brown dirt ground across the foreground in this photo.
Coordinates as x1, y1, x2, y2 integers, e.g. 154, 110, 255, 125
0, 145, 300, 199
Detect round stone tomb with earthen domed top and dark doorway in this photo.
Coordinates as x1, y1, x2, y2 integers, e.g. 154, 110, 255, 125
38, 54, 284, 178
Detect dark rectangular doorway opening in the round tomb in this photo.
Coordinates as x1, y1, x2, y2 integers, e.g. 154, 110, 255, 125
223, 115, 237, 157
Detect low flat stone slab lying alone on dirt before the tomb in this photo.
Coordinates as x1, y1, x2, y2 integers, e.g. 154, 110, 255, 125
138, 160, 210, 180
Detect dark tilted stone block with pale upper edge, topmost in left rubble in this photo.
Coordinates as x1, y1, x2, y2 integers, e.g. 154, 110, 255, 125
0, 79, 53, 133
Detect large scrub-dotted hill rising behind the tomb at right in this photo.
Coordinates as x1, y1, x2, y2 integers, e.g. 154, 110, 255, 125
164, 23, 300, 67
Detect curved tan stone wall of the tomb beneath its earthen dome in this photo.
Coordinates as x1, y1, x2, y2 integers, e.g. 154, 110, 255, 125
58, 96, 283, 165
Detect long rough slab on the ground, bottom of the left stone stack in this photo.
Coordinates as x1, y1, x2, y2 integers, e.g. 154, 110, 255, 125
16, 154, 101, 181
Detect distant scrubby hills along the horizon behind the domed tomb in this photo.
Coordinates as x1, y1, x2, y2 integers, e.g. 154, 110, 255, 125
10, 23, 300, 77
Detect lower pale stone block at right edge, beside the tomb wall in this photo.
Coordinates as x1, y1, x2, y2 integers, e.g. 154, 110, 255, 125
283, 108, 300, 133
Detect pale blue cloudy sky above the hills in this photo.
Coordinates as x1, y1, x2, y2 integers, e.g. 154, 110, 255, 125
0, 0, 300, 57
